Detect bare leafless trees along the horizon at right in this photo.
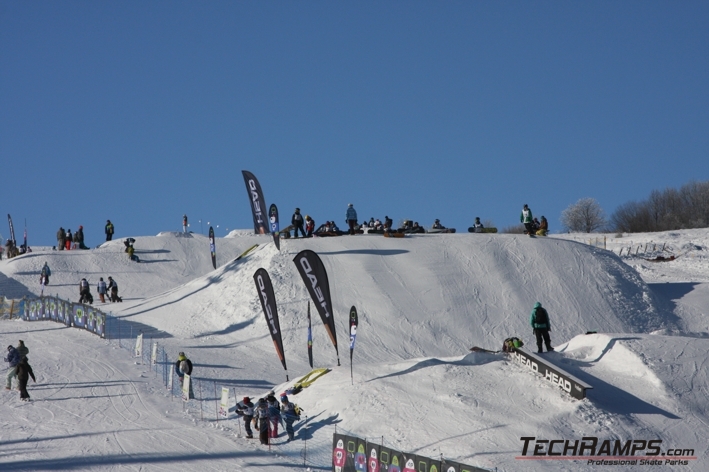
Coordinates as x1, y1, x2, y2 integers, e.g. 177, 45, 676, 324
561, 181, 709, 233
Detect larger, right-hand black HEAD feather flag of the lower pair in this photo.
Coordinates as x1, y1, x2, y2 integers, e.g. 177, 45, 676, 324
293, 249, 340, 366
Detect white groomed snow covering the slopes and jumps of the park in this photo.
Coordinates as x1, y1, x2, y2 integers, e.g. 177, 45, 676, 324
0, 229, 709, 471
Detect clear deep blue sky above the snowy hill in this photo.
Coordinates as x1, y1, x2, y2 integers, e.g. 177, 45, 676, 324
0, 0, 709, 246
